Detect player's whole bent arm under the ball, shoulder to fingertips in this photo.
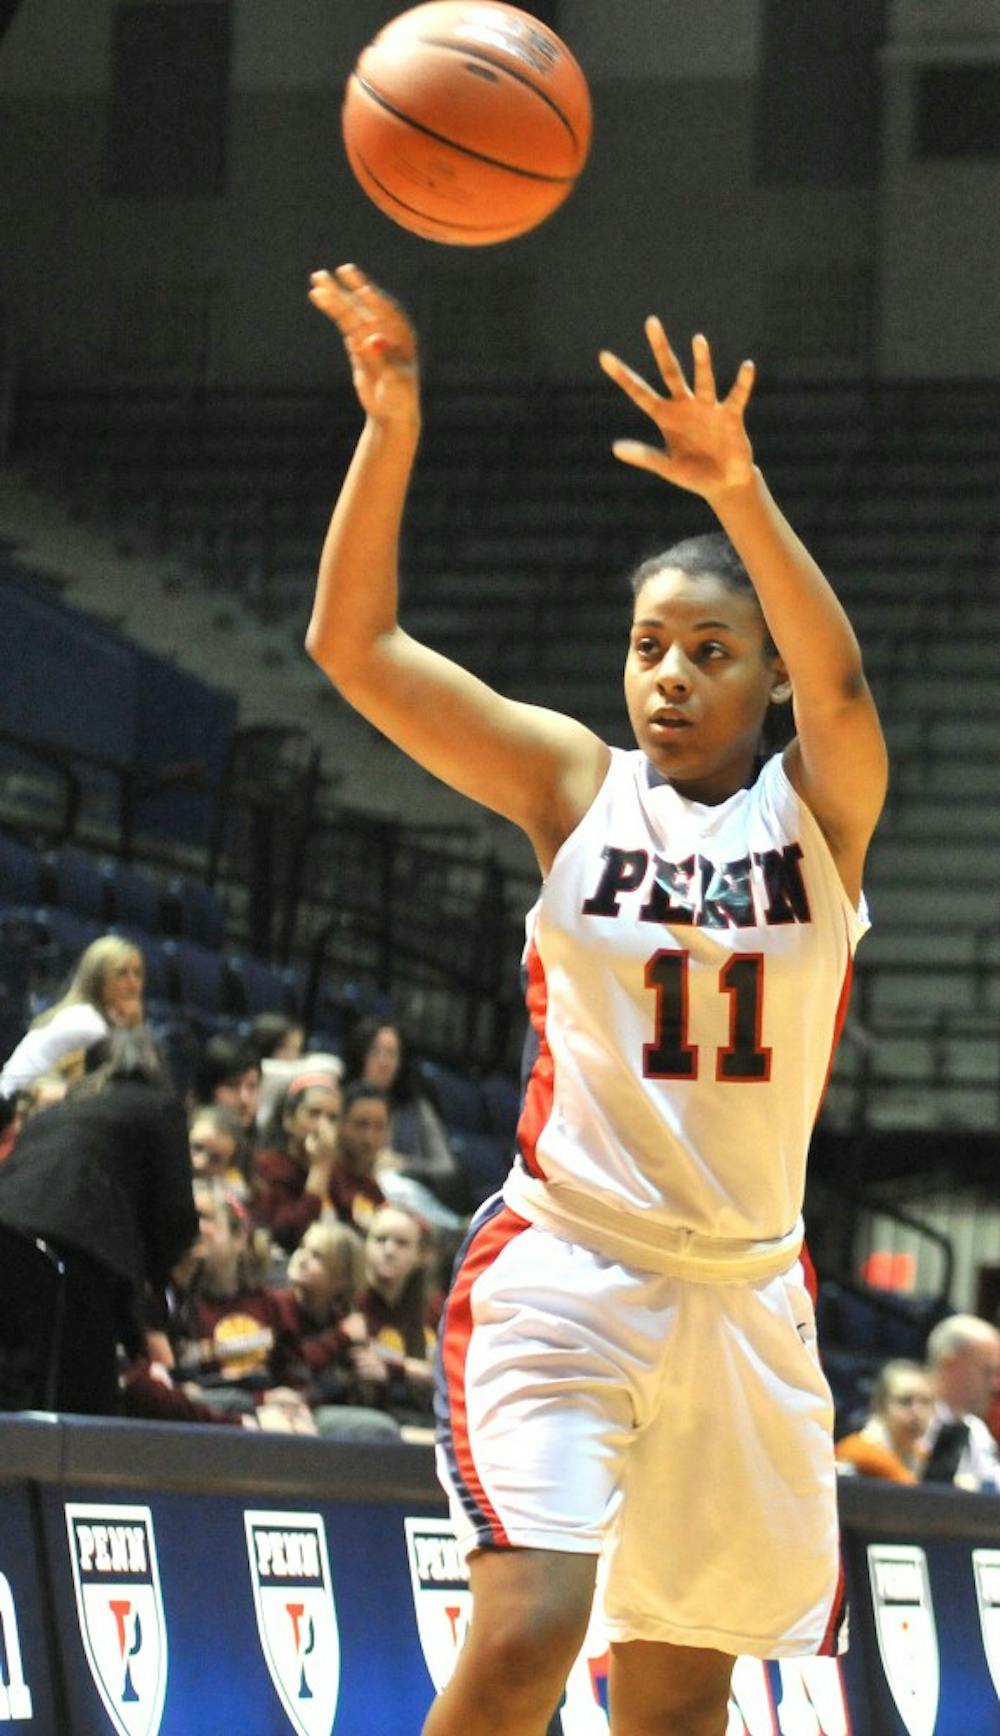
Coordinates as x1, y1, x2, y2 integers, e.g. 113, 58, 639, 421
306, 266, 608, 866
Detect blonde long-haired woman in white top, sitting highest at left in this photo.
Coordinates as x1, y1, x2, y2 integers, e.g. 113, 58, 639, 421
0, 934, 146, 1097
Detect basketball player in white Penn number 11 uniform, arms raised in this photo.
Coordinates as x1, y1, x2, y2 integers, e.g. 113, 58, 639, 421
307, 266, 885, 1736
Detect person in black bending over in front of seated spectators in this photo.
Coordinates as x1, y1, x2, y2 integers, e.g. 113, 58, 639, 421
0, 1029, 198, 1415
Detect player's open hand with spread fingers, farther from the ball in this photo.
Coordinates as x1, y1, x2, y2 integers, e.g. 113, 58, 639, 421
599, 314, 753, 502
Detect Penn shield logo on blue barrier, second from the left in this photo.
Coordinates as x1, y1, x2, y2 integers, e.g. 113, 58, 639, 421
243, 1512, 340, 1736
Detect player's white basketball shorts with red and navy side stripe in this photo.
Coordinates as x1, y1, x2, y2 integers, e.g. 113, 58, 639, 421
436, 1196, 844, 1658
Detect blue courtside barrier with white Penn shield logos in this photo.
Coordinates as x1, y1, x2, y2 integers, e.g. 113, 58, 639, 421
0, 1415, 1000, 1736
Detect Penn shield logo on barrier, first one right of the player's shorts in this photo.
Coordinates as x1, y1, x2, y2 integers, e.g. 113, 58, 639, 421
868, 1543, 941, 1736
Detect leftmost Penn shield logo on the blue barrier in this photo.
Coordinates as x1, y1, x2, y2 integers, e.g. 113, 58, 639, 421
66, 1502, 167, 1736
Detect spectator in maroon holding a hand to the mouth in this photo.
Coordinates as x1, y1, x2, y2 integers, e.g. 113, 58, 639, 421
253, 1069, 340, 1250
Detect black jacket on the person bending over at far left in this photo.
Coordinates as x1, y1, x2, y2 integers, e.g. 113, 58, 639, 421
0, 1080, 198, 1288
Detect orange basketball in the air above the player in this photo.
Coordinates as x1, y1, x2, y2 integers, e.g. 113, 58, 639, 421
342, 0, 590, 247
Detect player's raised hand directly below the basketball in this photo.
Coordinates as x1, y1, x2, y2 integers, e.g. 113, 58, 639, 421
309, 266, 420, 422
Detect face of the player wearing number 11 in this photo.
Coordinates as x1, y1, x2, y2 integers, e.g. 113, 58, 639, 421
625, 568, 783, 804
